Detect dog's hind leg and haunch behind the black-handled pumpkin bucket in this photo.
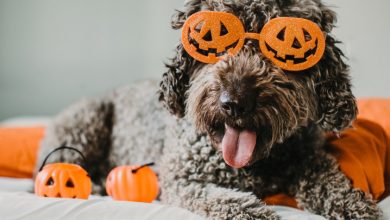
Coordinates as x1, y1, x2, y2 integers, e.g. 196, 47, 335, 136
37, 100, 113, 194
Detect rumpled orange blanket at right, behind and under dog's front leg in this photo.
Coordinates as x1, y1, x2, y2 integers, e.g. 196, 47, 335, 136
265, 119, 390, 208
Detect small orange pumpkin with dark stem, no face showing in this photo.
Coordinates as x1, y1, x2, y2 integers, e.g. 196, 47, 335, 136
106, 163, 159, 202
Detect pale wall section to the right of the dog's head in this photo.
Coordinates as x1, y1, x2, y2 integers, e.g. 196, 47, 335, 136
326, 0, 390, 97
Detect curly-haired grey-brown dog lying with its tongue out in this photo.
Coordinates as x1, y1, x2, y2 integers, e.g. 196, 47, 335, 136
40, 0, 380, 219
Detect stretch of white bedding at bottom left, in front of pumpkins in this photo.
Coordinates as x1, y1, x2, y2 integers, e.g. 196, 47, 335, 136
0, 192, 202, 220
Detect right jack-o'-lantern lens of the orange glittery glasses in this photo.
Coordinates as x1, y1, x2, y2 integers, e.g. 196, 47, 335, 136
260, 17, 325, 71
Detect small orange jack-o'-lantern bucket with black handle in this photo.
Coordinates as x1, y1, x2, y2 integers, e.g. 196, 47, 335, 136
34, 146, 92, 199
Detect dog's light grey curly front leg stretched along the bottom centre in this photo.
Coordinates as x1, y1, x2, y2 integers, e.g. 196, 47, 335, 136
161, 180, 279, 220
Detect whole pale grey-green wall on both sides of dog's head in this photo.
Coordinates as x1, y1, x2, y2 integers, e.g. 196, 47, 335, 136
0, 0, 390, 120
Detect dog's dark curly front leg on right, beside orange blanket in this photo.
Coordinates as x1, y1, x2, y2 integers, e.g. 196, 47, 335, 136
296, 156, 381, 219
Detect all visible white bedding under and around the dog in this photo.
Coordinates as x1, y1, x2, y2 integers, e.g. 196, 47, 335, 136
0, 117, 390, 220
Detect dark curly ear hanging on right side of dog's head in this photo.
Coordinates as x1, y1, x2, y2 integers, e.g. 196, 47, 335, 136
314, 36, 357, 132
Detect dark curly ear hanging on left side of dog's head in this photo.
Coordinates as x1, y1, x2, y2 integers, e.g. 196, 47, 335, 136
159, 44, 195, 117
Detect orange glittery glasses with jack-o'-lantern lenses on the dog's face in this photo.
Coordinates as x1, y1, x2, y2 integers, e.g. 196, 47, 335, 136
182, 11, 325, 71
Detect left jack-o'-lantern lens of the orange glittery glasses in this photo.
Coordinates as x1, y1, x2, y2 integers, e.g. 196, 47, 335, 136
182, 12, 245, 63
